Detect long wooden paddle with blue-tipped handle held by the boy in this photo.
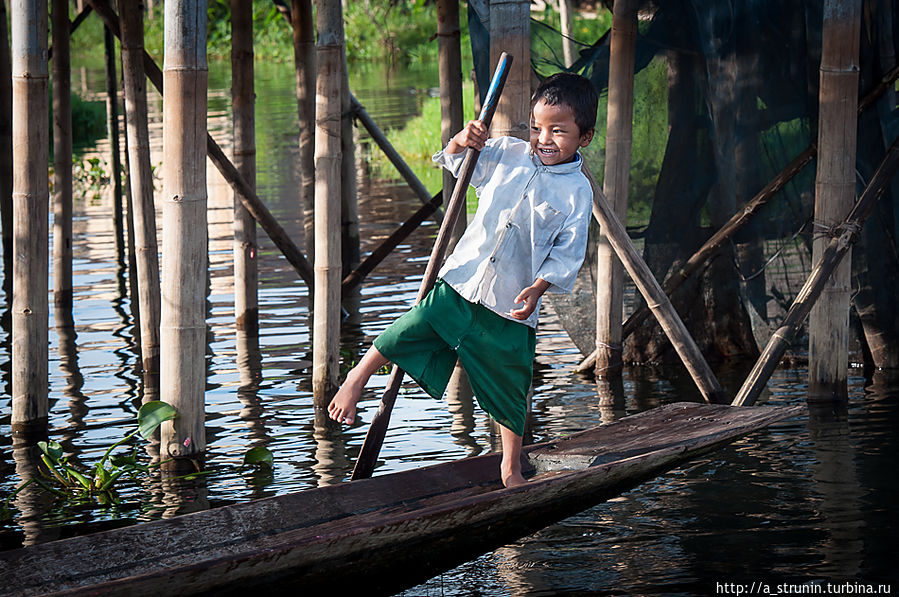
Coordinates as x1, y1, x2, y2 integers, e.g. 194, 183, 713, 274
351, 52, 512, 481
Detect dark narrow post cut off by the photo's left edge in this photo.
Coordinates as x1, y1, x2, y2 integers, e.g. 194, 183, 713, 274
0, 0, 13, 272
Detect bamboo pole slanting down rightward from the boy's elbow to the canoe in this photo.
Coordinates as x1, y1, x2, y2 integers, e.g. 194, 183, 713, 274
584, 167, 724, 404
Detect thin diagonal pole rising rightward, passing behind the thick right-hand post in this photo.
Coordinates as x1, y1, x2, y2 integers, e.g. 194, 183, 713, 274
577, 66, 899, 373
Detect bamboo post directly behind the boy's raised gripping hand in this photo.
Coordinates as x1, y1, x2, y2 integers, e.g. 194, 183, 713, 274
437, 0, 466, 244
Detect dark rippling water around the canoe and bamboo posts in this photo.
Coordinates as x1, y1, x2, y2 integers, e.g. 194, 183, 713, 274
0, 59, 899, 596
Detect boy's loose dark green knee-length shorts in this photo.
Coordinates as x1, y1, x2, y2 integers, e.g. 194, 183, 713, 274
374, 280, 537, 435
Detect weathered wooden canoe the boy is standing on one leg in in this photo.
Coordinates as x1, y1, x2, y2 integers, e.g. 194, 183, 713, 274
0, 403, 803, 597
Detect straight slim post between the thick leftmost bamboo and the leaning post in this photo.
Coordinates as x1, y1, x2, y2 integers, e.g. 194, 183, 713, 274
50, 0, 72, 316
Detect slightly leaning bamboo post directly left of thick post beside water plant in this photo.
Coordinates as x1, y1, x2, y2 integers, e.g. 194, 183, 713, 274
119, 0, 161, 393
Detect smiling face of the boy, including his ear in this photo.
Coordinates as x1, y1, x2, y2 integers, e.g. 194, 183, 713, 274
531, 100, 593, 166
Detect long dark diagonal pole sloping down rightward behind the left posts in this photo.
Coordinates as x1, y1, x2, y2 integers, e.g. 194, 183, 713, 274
86, 0, 313, 287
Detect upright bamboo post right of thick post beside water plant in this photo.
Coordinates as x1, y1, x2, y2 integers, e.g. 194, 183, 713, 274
231, 0, 259, 336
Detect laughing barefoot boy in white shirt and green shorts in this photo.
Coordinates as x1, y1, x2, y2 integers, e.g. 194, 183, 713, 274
328, 73, 597, 487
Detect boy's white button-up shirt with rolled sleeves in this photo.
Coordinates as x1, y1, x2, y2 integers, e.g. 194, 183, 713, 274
433, 137, 593, 327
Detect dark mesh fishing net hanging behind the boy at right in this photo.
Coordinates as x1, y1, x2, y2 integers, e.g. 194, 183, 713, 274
469, 0, 899, 362
